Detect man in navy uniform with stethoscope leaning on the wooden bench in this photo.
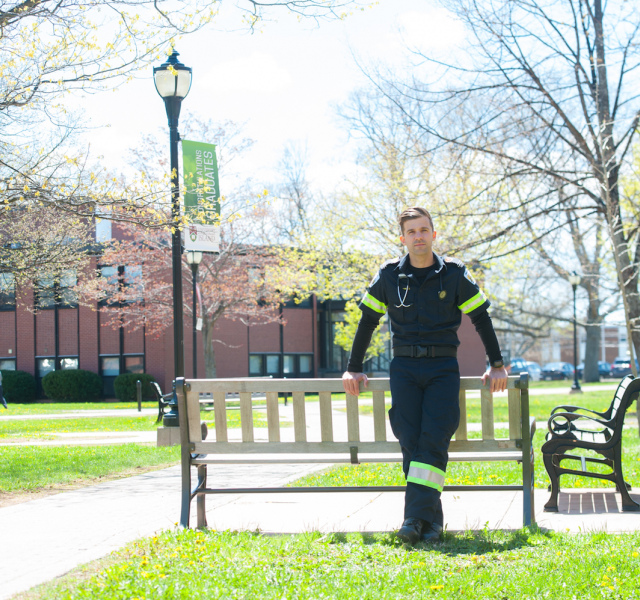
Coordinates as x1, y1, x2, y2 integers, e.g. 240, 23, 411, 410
342, 207, 507, 545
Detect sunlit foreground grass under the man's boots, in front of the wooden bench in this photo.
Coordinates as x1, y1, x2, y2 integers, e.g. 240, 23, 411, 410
17, 529, 640, 600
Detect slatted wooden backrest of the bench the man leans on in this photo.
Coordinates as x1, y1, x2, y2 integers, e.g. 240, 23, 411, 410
176, 374, 529, 454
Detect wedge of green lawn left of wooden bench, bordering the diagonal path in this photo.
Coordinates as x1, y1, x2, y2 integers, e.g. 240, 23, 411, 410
0, 444, 180, 492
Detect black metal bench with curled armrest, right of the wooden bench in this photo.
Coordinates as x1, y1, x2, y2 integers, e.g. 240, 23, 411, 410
542, 375, 640, 512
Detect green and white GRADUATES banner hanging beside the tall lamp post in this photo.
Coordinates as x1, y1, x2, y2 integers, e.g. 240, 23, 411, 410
182, 140, 220, 252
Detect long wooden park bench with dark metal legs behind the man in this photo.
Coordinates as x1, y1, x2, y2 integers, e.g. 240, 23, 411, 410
158, 374, 535, 527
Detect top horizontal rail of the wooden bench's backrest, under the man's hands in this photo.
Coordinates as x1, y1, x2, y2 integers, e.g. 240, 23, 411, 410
189, 377, 517, 394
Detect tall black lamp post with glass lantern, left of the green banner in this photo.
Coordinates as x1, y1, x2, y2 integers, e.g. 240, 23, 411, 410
153, 49, 191, 427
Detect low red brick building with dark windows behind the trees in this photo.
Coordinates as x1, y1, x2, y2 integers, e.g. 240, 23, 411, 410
0, 227, 486, 397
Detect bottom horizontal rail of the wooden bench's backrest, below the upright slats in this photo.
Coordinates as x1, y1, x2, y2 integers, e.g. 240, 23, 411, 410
193, 439, 517, 454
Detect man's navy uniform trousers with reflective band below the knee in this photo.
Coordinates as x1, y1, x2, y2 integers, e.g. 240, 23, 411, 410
389, 356, 460, 525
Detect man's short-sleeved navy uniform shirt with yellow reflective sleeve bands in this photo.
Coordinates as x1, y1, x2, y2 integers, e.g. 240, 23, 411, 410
360, 253, 489, 348
